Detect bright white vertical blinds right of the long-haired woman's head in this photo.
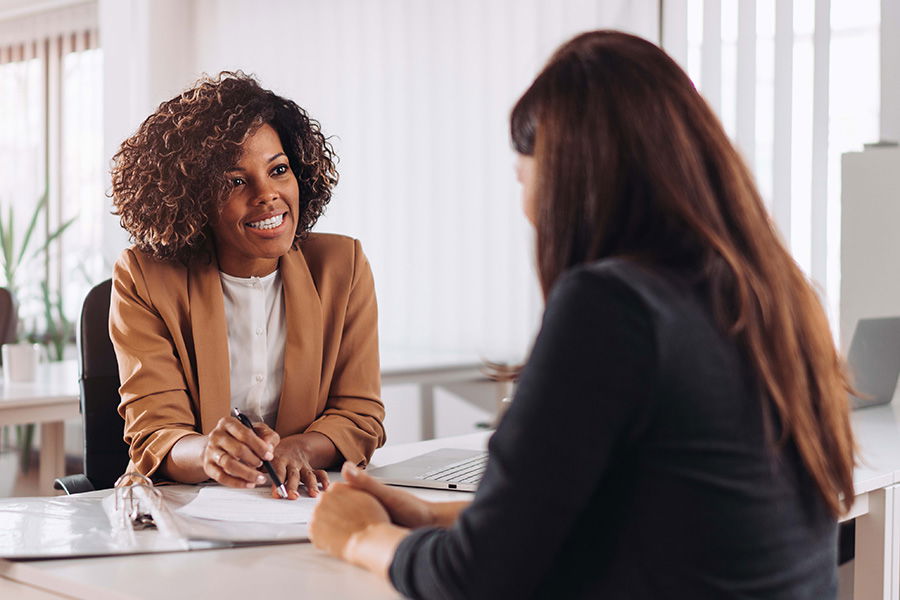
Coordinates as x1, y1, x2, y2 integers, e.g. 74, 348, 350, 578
661, 0, 880, 323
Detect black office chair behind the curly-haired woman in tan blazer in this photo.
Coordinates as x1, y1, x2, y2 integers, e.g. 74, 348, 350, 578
53, 279, 128, 494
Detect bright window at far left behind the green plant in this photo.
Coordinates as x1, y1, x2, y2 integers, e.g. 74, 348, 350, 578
0, 4, 103, 352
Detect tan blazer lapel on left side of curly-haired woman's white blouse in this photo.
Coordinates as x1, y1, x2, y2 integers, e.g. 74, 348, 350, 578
188, 259, 231, 433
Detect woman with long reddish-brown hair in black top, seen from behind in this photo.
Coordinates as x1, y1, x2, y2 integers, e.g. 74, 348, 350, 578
311, 31, 853, 600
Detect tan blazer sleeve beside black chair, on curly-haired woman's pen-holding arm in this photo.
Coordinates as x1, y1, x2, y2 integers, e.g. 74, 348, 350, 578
109, 250, 198, 477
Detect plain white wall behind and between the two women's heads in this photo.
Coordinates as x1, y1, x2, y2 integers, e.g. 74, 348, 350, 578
101, 0, 658, 358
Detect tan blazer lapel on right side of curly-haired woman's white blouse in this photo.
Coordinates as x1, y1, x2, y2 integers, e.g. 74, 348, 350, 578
275, 250, 323, 436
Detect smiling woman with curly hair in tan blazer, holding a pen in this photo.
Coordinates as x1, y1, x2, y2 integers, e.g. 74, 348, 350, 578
110, 72, 384, 498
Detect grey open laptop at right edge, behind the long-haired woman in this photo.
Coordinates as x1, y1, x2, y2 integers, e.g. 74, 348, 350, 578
847, 317, 900, 410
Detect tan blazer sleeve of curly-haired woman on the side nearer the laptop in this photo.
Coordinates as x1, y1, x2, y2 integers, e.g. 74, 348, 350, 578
307, 240, 385, 466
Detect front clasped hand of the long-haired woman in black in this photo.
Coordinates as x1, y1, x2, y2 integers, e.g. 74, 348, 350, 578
309, 483, 391, 564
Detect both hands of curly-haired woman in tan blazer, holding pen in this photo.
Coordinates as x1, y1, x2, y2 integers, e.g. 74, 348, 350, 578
202, 417, 328, 500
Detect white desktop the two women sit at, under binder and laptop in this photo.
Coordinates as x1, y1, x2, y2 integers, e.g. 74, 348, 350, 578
0, 432, 488, 600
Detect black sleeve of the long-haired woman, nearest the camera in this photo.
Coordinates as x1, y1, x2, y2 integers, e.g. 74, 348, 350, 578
390, 271, 657, 599
